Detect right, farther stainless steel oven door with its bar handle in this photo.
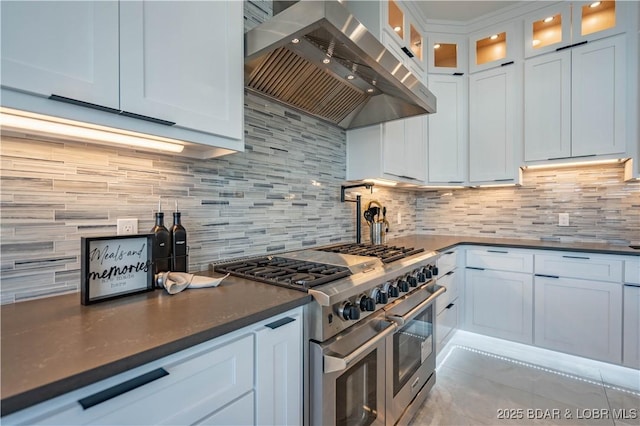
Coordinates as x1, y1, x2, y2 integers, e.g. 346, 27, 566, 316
386, 286, 446, 424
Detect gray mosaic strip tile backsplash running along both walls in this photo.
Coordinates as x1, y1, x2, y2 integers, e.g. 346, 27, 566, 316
0, 0, 640, 303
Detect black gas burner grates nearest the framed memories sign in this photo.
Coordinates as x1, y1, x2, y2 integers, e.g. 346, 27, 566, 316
214, 256, 351, 291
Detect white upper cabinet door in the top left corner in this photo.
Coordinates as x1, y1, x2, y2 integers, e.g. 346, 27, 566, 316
1, 1, 119, 109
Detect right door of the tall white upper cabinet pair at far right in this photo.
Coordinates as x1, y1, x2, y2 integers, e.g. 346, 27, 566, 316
571, 34, 627, 157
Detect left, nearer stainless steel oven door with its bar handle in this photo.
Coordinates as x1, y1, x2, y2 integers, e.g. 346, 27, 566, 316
310, 316, 396, 426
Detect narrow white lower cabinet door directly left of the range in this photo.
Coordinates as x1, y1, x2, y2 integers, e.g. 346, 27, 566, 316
256, 311, 302, 425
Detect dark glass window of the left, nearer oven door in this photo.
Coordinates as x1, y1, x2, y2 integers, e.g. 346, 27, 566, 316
336, 350, 378, 426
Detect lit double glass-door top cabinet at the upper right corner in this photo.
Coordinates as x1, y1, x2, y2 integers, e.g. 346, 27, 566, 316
524, 1, 626, 57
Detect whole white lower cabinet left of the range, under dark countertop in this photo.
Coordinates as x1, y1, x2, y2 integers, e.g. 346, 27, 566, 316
2, 308, 302, 425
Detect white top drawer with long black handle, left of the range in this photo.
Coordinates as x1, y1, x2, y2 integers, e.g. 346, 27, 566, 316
27, 335, 254, 425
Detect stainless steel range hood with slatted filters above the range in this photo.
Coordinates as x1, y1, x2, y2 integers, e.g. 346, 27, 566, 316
245, 0, 436, 129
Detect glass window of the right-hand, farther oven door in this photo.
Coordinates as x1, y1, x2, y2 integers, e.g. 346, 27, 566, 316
393, 305, 433, 396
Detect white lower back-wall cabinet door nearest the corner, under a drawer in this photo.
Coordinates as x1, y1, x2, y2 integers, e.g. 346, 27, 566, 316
464, 268, 533, 343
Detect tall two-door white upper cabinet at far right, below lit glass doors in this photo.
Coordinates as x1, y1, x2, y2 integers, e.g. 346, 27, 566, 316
524, 34, 627, 162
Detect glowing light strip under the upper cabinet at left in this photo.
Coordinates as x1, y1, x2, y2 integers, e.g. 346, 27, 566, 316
0, 108, 184, 153
